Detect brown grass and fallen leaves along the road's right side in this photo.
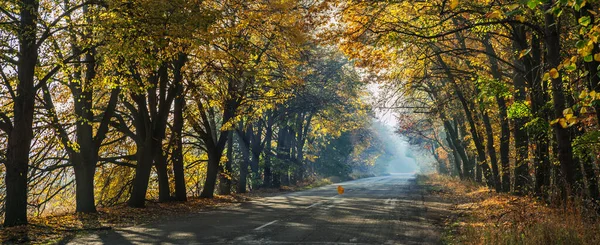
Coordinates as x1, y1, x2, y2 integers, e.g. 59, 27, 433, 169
417, 174, 600, 245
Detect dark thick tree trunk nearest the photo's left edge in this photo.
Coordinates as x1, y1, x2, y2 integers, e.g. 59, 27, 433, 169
4, 0, 39, 226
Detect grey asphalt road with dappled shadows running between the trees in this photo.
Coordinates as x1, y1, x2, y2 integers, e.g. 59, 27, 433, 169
68, 174, 449, 244
